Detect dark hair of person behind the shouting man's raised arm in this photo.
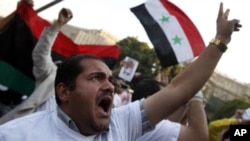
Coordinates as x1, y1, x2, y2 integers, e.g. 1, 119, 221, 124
132, 79, 165, 101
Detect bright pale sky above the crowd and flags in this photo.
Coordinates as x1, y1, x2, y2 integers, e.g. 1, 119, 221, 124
0, 0, 250, 83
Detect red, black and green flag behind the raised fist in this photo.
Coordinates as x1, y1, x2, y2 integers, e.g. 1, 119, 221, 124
0, 2, 120, 99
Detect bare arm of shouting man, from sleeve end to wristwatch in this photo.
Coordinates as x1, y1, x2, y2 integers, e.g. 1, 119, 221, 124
144, 44, 222, 125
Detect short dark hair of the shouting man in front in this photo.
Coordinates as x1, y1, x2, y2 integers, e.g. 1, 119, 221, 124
55, 55, 103, 105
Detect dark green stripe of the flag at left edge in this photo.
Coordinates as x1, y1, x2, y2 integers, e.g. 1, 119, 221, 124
0, 60, 35, 95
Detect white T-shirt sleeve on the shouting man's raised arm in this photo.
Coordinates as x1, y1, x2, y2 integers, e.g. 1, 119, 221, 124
110, 101, 152, 141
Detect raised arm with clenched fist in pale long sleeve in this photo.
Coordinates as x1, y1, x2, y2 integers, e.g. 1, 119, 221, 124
0, 7, 72, 124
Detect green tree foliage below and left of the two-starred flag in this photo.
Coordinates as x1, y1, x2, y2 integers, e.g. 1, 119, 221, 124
116, 37, 186, 88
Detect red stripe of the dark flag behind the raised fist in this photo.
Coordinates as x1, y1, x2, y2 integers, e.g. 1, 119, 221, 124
17, 3, 120, 59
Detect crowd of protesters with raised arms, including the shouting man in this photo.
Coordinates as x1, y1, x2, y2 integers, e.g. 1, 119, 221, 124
0, 0, 247, 141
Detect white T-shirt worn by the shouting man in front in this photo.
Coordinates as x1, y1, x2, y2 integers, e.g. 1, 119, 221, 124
0, 101, 149, 141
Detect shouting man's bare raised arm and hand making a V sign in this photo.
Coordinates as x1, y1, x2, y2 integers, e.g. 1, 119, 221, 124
143, 3, 240, 126
